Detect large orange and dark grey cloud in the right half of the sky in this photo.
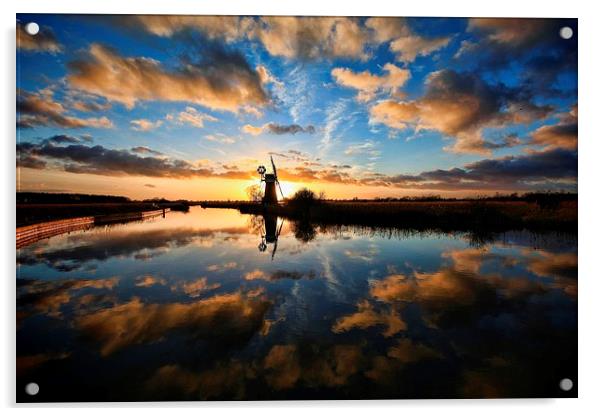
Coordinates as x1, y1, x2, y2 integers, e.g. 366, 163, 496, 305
370, 69, 552, 154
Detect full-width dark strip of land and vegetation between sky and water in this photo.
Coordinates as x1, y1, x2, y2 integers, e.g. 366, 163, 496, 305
17, 189, 578, 233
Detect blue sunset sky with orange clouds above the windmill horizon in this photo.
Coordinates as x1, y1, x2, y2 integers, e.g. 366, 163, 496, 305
16, 14, 577, 200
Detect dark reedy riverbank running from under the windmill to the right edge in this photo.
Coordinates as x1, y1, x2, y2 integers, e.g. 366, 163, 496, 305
200, 200, 577, 233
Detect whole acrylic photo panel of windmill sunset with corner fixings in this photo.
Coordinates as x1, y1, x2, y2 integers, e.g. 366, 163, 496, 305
16, 14, 578, 402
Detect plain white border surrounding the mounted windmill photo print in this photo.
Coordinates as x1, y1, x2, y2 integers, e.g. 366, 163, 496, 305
0, 0, 602, 416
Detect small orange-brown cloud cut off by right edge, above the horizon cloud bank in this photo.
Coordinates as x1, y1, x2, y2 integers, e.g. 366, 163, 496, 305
531, 105, 578, 150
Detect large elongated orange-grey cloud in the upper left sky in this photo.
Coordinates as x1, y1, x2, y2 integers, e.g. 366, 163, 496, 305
67, 44, 269, 112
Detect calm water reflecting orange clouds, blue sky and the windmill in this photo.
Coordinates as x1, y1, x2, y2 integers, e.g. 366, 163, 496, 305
17, 207, 577, 401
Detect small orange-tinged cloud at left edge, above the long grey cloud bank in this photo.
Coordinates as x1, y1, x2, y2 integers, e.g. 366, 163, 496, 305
17, 89, 113, 128
